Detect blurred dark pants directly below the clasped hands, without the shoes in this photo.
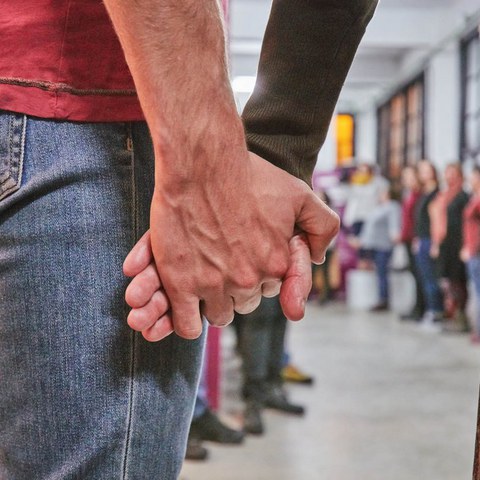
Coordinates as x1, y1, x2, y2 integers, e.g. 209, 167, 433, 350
235, 297, 287, 402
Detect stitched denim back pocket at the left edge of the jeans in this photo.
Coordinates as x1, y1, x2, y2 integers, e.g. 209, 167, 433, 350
0, 111, 27, 200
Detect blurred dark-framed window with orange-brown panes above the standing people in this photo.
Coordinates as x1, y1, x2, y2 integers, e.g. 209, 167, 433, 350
377, 74, 425, 179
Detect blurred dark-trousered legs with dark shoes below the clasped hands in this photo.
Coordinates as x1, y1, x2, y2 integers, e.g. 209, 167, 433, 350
235, 297, 305, 435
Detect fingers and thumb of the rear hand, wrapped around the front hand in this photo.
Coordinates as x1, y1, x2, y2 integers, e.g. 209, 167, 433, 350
124, 231, 312, 342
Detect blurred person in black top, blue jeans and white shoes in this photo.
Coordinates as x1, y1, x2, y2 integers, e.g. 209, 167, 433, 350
412, 160, 443, 328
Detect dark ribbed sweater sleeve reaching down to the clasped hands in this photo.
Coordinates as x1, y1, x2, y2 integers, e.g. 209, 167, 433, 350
243, 0, 377, 184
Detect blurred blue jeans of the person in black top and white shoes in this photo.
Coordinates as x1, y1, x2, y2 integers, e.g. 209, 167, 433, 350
415, 237, 443, 312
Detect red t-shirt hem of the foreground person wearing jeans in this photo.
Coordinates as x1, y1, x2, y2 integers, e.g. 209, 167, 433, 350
0, 0, 143, 121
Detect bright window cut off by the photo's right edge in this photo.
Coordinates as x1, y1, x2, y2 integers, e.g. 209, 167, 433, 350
460, 29, 480, 164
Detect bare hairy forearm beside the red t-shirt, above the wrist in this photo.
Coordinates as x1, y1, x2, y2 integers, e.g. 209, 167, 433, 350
104, 0, 246, 182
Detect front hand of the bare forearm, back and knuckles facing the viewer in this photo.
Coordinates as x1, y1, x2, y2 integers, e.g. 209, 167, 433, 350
150, 154, 339, 338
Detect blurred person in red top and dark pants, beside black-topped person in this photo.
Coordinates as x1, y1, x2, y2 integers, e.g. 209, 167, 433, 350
400, 166, 425, 320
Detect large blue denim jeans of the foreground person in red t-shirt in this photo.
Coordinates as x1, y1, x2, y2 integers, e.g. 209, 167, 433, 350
0, 112, 203, 480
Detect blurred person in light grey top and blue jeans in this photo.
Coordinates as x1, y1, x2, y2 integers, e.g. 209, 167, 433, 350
358, 187, 401, 311
